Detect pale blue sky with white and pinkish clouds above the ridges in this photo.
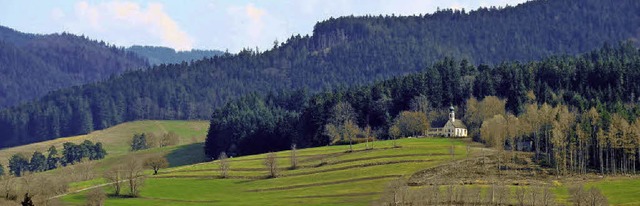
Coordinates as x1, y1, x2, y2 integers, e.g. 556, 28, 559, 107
0, 0, 525, 52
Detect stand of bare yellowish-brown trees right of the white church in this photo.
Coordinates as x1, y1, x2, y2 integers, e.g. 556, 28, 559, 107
480, 98, 640, 175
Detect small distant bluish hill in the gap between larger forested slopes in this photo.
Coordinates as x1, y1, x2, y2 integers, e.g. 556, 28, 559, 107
127, 45, 224, 65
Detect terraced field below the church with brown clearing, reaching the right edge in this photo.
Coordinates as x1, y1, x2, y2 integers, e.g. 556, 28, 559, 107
62, 138, 640, 205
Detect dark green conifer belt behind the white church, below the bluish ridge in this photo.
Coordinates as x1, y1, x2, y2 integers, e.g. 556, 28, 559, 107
205, 44, 640, 157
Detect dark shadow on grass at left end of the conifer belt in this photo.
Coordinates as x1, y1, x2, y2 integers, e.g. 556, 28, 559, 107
166, 143, 206, 167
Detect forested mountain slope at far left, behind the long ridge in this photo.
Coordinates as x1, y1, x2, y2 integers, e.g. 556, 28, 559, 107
0, 26, 147, 108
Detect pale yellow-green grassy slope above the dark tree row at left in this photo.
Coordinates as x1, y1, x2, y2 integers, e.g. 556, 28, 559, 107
0, 120, 208, 165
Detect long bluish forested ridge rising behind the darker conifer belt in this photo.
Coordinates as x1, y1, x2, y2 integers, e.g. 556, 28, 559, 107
0, 0, 640, 146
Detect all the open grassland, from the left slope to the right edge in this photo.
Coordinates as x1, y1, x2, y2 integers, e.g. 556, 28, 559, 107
7, 121, 640, 205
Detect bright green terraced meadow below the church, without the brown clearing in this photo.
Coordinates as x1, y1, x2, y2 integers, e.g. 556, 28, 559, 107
63, 138, 466, 205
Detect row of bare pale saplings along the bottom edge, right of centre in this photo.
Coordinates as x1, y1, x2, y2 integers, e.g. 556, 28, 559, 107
376, 179, 609, 206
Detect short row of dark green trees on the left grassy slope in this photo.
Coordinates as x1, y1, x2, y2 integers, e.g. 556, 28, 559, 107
9, 140, 107, 177
